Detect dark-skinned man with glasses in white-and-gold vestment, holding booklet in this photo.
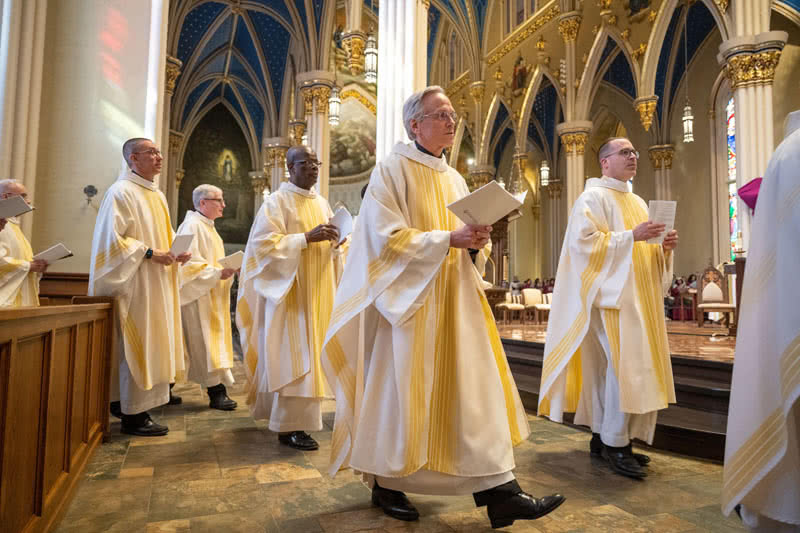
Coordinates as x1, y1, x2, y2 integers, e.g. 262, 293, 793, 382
236, 146, 340, 450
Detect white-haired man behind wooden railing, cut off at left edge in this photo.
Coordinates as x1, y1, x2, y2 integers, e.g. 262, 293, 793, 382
0, 180, 47, 308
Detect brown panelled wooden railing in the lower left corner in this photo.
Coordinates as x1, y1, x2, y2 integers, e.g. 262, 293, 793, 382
0, 299, 115, 533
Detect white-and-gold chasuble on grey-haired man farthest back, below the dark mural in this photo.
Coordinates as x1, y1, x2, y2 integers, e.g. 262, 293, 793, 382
176, 211, 233, 385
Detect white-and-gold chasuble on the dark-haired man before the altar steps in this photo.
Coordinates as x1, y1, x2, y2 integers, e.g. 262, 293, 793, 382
539, 176, 675, 422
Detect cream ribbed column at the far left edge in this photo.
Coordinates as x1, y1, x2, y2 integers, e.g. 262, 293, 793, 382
0, 0, 47, 237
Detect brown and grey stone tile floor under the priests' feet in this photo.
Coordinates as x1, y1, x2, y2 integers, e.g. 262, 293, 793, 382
57, 363, 742, 533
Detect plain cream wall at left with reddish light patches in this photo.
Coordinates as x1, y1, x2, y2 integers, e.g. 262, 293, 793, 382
31, 0, 159, 272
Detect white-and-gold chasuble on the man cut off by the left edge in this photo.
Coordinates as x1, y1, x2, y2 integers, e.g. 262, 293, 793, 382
0, 218, 42, 307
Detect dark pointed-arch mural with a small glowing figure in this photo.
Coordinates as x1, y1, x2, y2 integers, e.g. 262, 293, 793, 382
178, 104, 254, 245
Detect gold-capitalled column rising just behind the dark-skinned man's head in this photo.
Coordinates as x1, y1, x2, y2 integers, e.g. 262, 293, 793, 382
297, 70, 333, 198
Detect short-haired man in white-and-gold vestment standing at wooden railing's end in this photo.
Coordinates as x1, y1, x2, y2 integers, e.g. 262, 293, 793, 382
89, 138, 191, 436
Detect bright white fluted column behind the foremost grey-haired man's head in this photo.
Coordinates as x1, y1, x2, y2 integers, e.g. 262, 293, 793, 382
375, 0, 432, 161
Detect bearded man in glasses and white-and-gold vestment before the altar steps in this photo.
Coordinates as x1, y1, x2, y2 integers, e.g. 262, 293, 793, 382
539, 138, 678, 478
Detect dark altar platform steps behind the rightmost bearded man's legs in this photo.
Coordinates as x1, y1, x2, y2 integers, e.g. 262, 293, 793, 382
502, 339, 733, 461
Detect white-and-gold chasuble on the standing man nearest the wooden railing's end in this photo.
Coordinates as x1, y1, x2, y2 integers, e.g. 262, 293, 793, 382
89, 169, 184, 390
